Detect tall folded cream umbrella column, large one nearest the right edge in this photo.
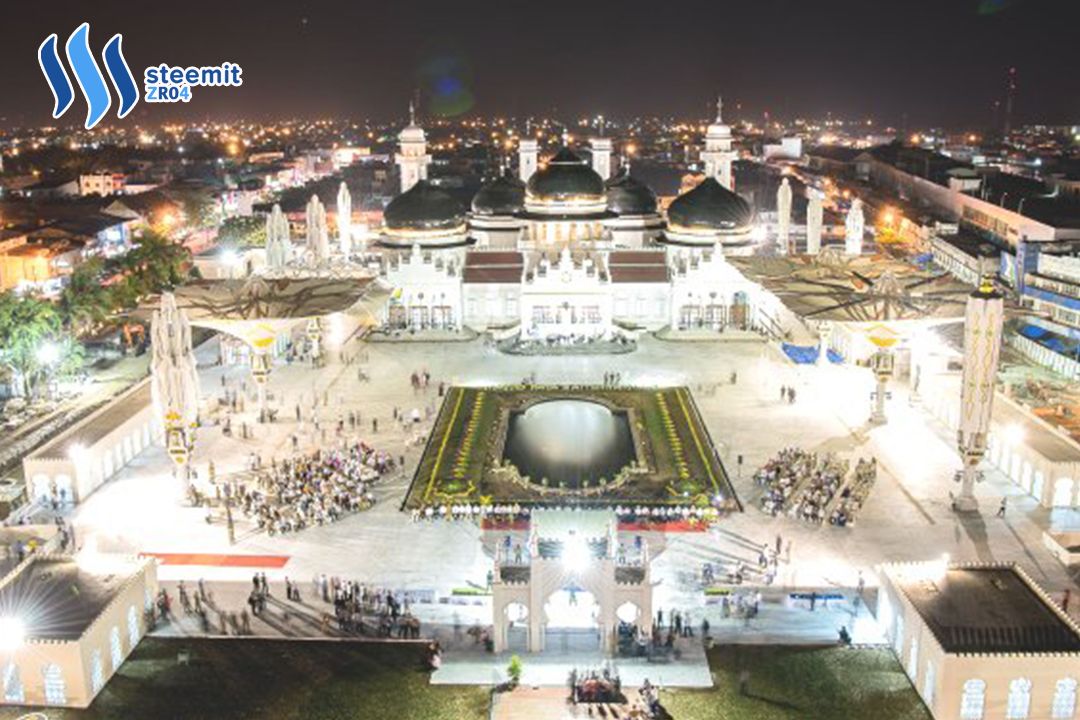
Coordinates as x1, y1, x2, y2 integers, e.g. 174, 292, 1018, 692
955, 279, 1004, 511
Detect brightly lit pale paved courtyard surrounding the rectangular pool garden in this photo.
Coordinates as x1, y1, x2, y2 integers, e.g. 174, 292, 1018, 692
61, 337, 1080, 648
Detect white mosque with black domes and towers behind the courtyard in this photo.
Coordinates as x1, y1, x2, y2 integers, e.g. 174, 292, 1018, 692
377, 97, 783, 341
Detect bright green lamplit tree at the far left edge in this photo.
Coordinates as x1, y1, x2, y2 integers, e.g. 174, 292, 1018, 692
0, 293, 62, 397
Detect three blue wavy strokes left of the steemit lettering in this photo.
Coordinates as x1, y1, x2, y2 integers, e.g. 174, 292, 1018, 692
38, 23, 138, 130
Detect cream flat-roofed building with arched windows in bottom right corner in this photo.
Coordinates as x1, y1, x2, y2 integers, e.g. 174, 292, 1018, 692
878, 559, 1080, 720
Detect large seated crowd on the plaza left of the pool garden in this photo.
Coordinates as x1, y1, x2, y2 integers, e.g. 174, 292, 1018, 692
229, 441, 396, 535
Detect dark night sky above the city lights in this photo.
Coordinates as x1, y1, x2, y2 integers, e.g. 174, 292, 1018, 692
0, 0, 1080, 127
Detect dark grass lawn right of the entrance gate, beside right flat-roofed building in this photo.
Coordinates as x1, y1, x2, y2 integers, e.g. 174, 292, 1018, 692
661, 646, 931, 720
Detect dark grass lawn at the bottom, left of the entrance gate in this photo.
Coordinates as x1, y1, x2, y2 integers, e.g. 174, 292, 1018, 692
0, 638, 488, 720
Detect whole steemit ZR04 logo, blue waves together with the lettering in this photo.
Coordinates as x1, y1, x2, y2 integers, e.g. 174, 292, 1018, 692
38, 23, 244, 130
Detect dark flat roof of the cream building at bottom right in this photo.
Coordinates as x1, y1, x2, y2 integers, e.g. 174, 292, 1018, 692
889, 563, 1080, 653
